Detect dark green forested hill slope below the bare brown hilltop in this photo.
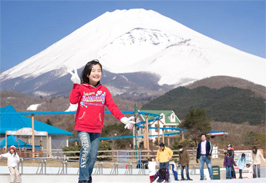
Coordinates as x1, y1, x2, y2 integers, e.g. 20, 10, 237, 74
142, 86, 265, 125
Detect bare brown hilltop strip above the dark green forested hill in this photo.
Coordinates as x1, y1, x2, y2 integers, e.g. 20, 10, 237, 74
185, 76, 266, 99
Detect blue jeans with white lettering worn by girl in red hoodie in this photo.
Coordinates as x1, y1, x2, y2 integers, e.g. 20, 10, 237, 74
78, 131, 101, 181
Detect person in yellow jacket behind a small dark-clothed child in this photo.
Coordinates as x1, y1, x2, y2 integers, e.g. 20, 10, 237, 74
156, 143, 173, 170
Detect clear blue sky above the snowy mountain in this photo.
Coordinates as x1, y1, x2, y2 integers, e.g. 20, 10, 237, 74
1, 0, 266, 72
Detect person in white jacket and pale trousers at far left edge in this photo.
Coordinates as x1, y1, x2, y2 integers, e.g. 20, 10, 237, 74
0, 146, 20, 183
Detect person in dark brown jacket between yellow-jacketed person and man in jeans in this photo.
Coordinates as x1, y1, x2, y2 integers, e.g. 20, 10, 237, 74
178, 145, 192, 181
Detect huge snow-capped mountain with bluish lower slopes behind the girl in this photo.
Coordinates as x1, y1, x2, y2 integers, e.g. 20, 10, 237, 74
0, 9, 266, 95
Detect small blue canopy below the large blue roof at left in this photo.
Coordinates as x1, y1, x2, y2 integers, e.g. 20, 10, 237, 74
0, 135, 40, 149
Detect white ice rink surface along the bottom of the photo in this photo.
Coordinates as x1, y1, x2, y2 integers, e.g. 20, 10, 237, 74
0, 167, 266, 183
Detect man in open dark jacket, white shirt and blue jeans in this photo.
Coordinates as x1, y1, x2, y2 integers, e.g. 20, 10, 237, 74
196, 134, 213, 180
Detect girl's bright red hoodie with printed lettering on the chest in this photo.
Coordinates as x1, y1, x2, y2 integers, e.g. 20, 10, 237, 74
69, 83, 124, 133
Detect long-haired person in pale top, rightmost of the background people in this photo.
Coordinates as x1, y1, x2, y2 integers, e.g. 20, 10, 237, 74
251, 146, 265, 178
